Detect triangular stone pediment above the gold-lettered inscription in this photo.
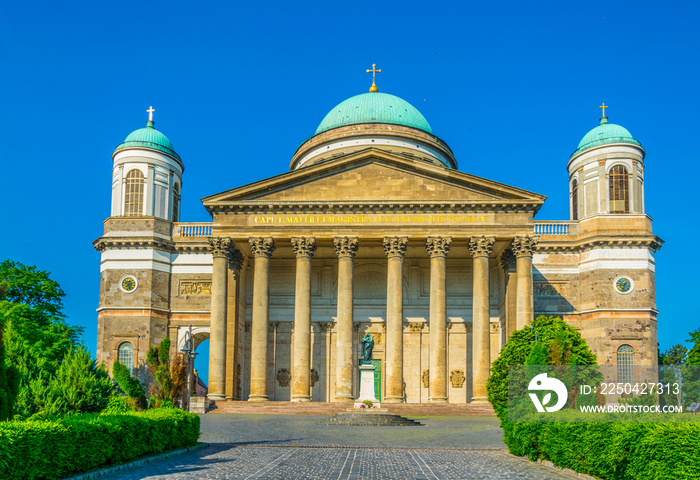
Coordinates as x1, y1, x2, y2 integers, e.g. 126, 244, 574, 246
202, 148, 545, 207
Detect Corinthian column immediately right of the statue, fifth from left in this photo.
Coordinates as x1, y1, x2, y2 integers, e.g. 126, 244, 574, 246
384, 237, 408, 403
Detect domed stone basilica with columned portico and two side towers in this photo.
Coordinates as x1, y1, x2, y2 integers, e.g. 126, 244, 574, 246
94, 73, 662, 403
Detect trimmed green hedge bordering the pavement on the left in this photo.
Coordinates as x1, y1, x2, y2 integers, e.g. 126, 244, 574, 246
0, 408, 199, 480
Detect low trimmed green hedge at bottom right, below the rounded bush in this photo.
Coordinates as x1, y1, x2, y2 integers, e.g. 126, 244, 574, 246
503, 422, 700, 480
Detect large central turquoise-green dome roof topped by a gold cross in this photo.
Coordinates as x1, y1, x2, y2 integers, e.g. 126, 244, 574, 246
316, 92, 433, 135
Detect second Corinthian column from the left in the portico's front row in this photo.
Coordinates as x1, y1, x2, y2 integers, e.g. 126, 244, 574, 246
248, 237, 275, 402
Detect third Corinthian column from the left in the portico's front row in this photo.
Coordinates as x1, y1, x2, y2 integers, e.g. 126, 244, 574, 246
292, 237, 316, 402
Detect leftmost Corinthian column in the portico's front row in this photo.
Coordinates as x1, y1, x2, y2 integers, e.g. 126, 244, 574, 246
207, 237, 233, 400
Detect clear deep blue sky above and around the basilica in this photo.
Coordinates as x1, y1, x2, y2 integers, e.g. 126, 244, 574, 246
0, 0, 700, 378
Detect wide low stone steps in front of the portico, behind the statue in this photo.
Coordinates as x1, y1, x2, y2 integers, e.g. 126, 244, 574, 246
207, 400, 495, 417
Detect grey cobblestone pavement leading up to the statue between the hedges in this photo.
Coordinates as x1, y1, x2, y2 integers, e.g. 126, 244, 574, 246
101, 415, 572, 480
